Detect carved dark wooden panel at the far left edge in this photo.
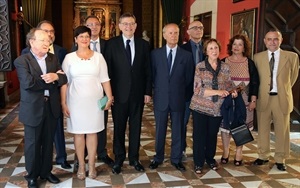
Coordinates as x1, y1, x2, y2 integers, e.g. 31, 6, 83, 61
0, 0, 12, 71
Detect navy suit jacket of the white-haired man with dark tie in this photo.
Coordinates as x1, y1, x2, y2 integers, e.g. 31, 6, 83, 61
151, 46, 195, 112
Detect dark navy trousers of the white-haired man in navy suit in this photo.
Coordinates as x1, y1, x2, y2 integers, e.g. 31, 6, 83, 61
154, 109, 184, 163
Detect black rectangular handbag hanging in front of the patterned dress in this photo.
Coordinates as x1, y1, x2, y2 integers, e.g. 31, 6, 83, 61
230, 124, 254, 146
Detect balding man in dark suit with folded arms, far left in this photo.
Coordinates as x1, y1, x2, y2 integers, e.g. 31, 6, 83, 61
14, 28, 67, 187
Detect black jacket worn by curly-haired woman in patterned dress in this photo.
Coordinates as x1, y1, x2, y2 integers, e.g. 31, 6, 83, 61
221, 58, 259, 102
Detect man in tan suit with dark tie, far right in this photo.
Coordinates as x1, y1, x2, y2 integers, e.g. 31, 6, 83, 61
254, 29, 299, 171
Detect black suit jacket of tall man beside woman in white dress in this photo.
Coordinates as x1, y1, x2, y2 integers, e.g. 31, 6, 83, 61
104, 35, 152, 103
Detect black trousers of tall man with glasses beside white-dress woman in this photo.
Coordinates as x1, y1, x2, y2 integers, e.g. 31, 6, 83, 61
112, 96, 144, 164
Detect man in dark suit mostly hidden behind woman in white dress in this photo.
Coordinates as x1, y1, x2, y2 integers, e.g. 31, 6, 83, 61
71, 15, 114, 167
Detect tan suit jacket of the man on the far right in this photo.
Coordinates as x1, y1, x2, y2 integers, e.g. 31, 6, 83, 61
254, 50, 299, 114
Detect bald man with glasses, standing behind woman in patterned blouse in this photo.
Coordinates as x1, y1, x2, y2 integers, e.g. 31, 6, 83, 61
180, 21, 205, 155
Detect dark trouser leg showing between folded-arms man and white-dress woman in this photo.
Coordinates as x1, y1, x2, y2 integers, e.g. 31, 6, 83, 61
54, 114, 67, 164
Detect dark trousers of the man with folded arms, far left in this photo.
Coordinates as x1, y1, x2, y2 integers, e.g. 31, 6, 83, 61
24, 101, 57, 180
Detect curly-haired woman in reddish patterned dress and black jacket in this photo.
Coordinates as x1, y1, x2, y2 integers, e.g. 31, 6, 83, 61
221, 35, 259, 166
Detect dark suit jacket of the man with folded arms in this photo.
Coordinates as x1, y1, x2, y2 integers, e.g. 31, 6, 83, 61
14, 53, 67, 126
